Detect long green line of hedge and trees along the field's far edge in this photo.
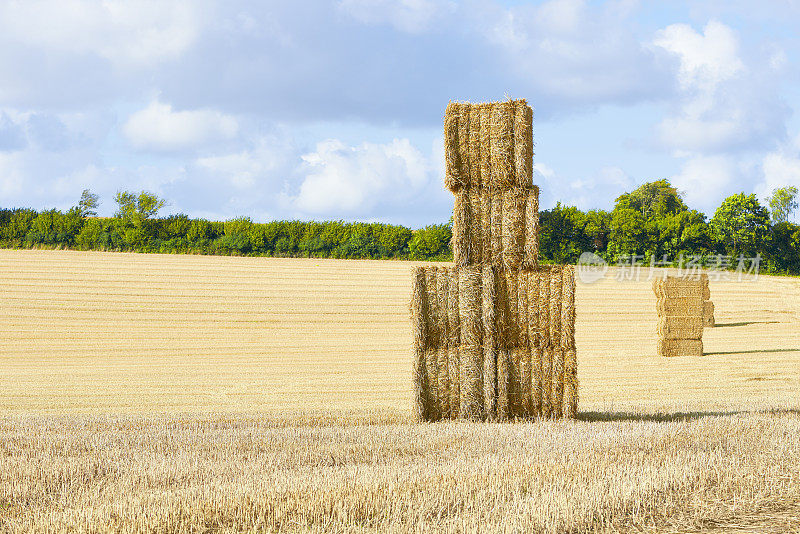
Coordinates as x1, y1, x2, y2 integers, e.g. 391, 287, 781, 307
0, 180, 800, 274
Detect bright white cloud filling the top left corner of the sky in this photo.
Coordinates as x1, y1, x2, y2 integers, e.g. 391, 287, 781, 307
0, 0, 201, 65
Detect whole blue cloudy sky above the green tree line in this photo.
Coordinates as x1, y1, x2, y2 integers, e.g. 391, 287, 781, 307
0, 0, 800, 227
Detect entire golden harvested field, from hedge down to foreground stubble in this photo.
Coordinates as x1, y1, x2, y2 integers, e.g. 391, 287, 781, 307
0, 250, 800, 532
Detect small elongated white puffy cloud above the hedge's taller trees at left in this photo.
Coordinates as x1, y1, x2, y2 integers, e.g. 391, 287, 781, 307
123, 101, 239, 151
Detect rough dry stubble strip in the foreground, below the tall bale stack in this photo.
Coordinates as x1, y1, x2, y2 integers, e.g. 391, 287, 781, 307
0, 413, 800, 532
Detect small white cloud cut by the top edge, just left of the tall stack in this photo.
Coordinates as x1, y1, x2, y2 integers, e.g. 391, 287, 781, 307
339, 0, 456, 33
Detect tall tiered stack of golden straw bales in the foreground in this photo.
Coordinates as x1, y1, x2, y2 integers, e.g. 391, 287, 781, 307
411, 100, 578, 421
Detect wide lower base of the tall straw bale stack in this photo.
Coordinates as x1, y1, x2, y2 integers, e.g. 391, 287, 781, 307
411, 266, 578, 421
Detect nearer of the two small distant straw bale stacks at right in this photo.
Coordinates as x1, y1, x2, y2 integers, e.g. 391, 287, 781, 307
653, 275, 708, 356
